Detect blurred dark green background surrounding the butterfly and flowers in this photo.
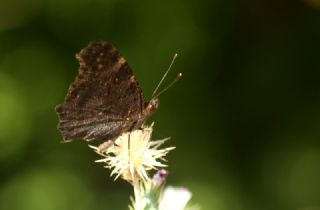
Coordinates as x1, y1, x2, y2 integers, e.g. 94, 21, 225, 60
0, 0, 320, 210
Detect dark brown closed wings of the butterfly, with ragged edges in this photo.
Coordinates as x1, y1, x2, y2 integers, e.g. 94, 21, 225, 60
56, 41, 144, 140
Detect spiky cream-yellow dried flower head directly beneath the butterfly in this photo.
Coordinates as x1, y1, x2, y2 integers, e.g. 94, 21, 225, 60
91, 124, 174, 182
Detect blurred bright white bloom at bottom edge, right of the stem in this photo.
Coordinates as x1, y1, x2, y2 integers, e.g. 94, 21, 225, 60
159, 187, 191, 210
